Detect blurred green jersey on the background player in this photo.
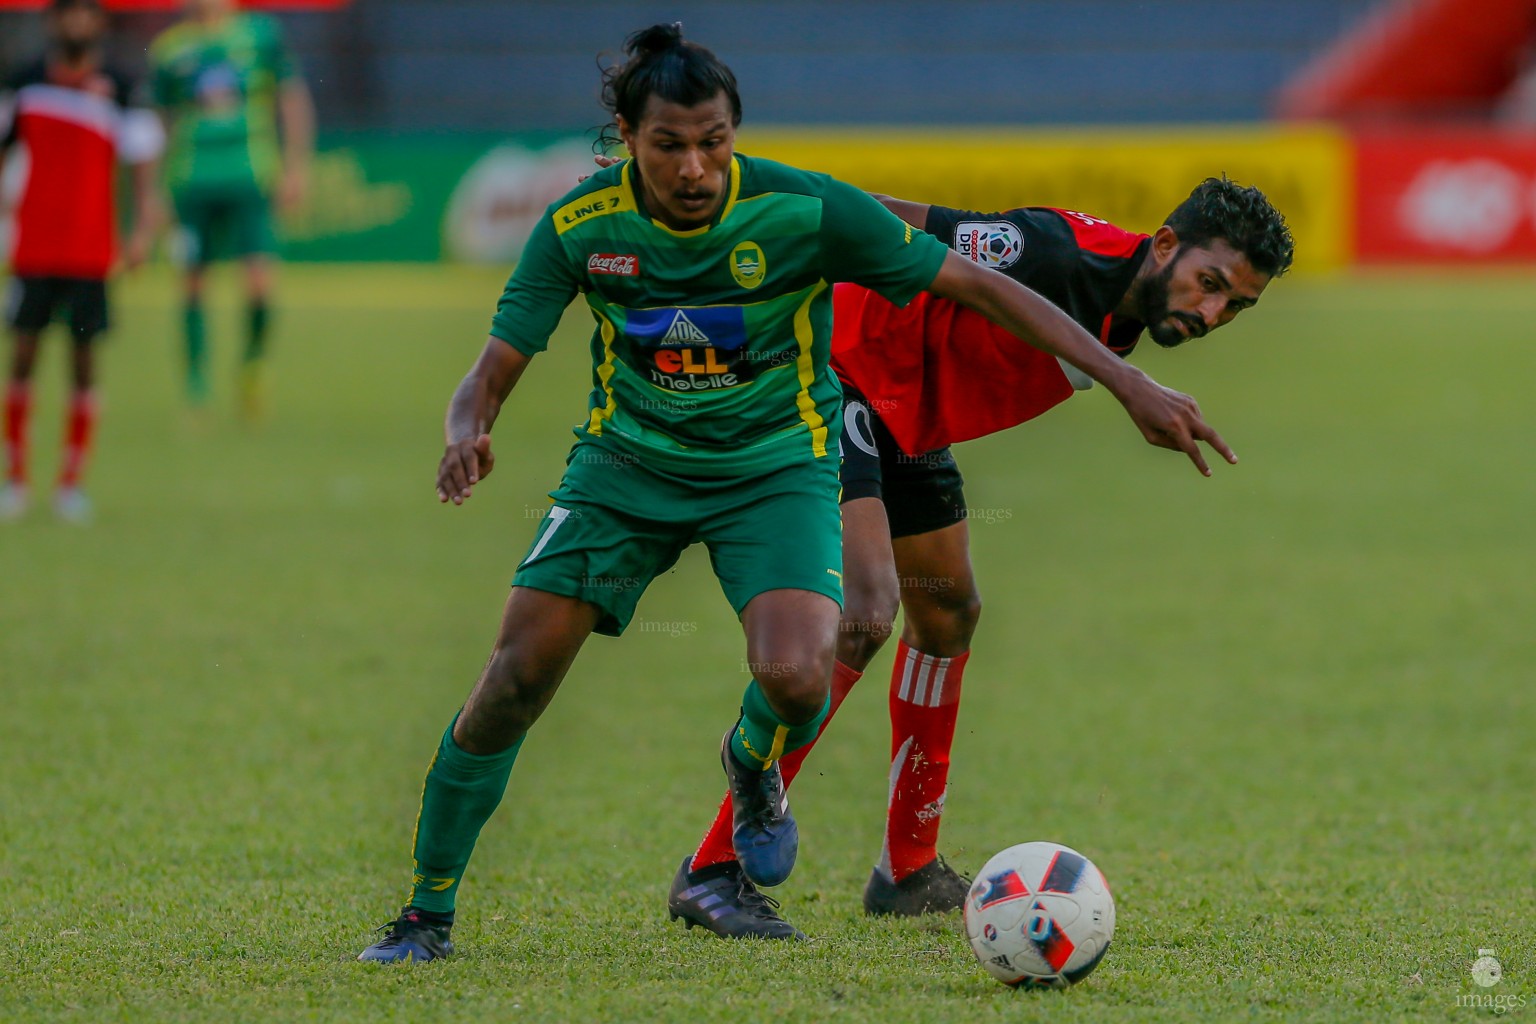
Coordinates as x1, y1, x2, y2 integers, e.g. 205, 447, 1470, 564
149, 14, 296, 190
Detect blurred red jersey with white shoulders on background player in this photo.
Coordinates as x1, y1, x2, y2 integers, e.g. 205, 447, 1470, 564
0, 60, 160, 279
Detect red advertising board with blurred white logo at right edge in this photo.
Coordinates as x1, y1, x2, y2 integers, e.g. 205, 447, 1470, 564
1355, 129, 1536, 263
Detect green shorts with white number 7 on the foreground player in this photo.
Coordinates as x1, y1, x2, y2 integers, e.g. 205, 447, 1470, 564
511, 442, 843, 637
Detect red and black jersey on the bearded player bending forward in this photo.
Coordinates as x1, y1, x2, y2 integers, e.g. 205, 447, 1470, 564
833, 206, 1152, 454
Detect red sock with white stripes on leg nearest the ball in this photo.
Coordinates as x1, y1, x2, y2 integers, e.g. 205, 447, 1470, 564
880, 640, 971, 881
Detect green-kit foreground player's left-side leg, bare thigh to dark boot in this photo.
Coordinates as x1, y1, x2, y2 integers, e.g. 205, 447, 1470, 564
358, 586, 602, 963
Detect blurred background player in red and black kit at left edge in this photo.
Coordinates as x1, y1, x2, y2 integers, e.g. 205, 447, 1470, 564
0, 0, 164, 522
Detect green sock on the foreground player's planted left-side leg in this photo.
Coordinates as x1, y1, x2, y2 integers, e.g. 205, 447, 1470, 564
407, 715, 524, 913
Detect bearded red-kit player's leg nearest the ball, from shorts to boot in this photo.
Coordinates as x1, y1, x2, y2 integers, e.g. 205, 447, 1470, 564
865, 448, 980, 913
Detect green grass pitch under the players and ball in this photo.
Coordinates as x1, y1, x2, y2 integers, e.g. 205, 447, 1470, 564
0, 266, 1536, 1022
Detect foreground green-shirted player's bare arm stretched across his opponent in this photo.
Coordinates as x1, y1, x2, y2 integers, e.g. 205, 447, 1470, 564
928, 252, 1238, 476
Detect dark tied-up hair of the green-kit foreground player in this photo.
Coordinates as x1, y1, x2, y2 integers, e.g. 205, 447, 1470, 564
598, 21, 742, 146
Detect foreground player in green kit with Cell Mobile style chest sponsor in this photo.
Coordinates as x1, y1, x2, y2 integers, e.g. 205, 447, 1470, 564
359, 25, 1236, 963
